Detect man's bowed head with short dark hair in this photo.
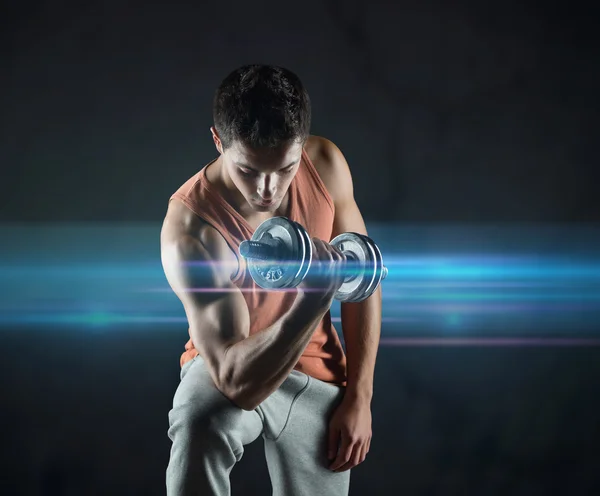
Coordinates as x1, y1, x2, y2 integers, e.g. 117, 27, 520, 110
211, 65, 311, 212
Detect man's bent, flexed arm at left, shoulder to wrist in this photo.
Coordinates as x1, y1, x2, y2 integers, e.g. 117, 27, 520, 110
161, 201, 333, 410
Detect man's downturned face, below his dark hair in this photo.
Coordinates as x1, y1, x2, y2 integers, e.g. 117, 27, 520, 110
222, 141, 302, 212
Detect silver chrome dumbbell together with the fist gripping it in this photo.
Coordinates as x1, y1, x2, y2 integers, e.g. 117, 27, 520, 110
240, 217, 387, 302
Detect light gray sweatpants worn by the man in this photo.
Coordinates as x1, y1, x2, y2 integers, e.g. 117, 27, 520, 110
166, 356, 350, 496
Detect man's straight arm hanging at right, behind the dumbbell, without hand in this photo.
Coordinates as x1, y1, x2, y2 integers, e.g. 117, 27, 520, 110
315, 138, 381, 403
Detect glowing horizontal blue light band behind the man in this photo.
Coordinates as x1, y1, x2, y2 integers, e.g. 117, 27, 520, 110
0, 225, 600, 346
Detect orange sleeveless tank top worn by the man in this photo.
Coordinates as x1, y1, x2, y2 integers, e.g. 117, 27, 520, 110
171, 150, 346, 386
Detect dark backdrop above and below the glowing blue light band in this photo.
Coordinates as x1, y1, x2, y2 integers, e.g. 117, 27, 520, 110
0, 0, 600, 496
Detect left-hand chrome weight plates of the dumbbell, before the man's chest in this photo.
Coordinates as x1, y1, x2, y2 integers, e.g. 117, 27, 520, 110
247, 217, 312, 289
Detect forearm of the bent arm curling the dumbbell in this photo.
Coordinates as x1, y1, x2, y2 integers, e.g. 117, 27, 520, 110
219, 295, 329, 410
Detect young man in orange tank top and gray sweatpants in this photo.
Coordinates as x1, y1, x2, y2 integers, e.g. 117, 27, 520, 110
161, 65, 381, 496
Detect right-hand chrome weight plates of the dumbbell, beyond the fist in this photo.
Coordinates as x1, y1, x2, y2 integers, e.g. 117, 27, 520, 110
330, 232, 383, 303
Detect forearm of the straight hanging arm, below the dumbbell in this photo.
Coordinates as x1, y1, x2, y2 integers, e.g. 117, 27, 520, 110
341, 287, 381, 402
